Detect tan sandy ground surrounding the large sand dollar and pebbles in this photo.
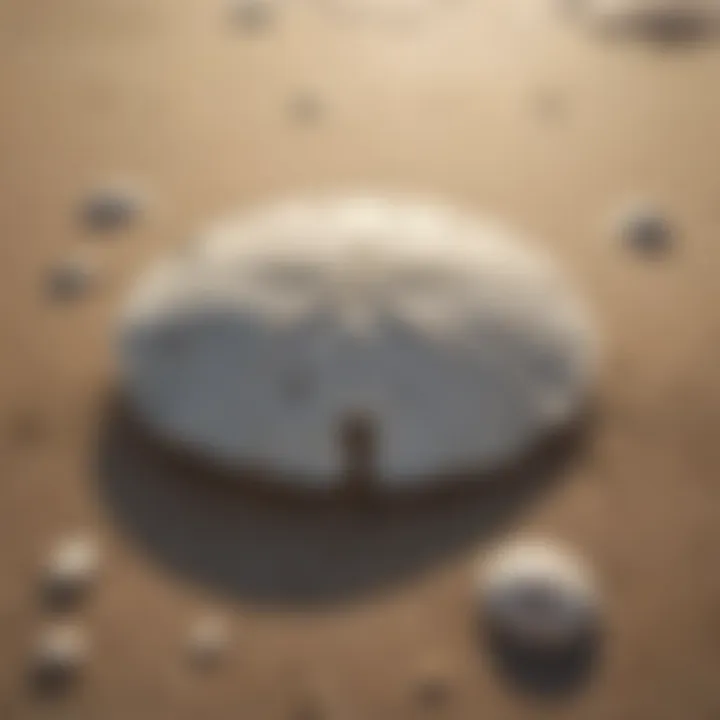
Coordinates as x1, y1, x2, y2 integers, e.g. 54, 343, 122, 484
0, 0, 720, 720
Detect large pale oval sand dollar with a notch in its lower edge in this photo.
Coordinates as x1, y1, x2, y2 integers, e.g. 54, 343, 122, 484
119, 198, 595, 486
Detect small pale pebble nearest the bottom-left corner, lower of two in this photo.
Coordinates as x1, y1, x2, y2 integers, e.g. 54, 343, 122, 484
31, 624, 89, 687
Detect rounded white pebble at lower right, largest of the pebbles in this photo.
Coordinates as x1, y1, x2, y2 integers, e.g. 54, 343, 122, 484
478, 540, 599, 650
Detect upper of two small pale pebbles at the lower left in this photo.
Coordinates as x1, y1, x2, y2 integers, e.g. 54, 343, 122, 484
45, 536, 100, 605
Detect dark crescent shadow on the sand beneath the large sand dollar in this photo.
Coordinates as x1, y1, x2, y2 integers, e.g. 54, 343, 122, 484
98, 401, 590, 607
